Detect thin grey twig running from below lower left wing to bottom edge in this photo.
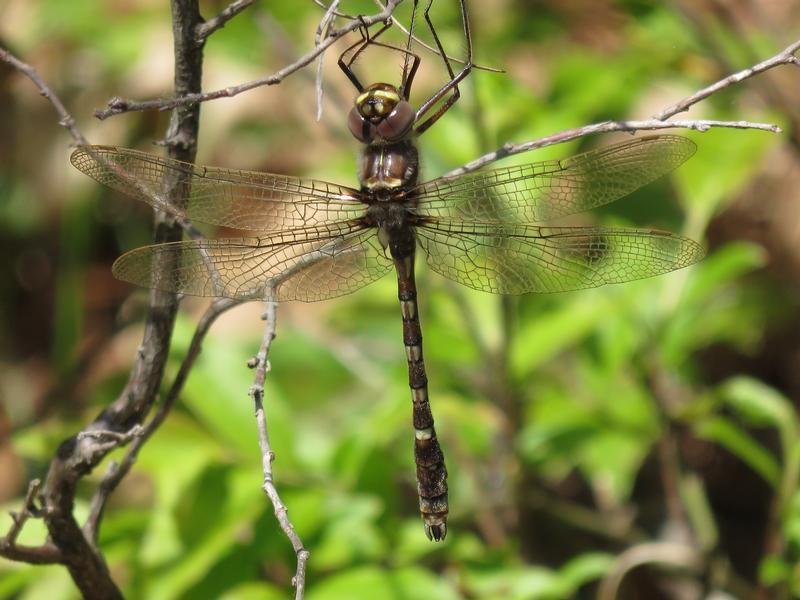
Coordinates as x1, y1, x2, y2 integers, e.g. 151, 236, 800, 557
250, 302, 309, 600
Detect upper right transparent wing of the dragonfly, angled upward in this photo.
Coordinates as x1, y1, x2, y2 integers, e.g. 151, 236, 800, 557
413, 135, 696, 223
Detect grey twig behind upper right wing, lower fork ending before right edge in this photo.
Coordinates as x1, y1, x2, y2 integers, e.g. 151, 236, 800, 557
445, 119, 781, 177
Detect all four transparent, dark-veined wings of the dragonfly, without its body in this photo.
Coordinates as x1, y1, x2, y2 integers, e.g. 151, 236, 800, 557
72, 135, 703, 302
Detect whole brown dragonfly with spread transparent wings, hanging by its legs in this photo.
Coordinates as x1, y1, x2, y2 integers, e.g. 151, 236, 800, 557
71, 0, 704, 541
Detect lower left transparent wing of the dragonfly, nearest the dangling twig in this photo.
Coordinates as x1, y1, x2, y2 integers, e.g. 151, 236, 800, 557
113, 226, 392, 302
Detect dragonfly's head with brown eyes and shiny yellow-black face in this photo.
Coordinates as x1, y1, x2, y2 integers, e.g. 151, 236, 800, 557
348, 83, 416, 144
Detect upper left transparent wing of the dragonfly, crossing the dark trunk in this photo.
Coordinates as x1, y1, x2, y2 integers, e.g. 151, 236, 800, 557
70, 146, 364, 231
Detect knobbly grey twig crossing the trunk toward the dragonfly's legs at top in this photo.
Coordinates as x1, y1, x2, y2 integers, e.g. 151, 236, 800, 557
94, 0, 402, 119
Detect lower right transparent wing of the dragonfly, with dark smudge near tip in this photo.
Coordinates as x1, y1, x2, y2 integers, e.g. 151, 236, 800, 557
417, 223, 704, 294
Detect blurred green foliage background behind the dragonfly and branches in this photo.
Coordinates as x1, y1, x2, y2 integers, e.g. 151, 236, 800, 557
0, 0, 800, 600
